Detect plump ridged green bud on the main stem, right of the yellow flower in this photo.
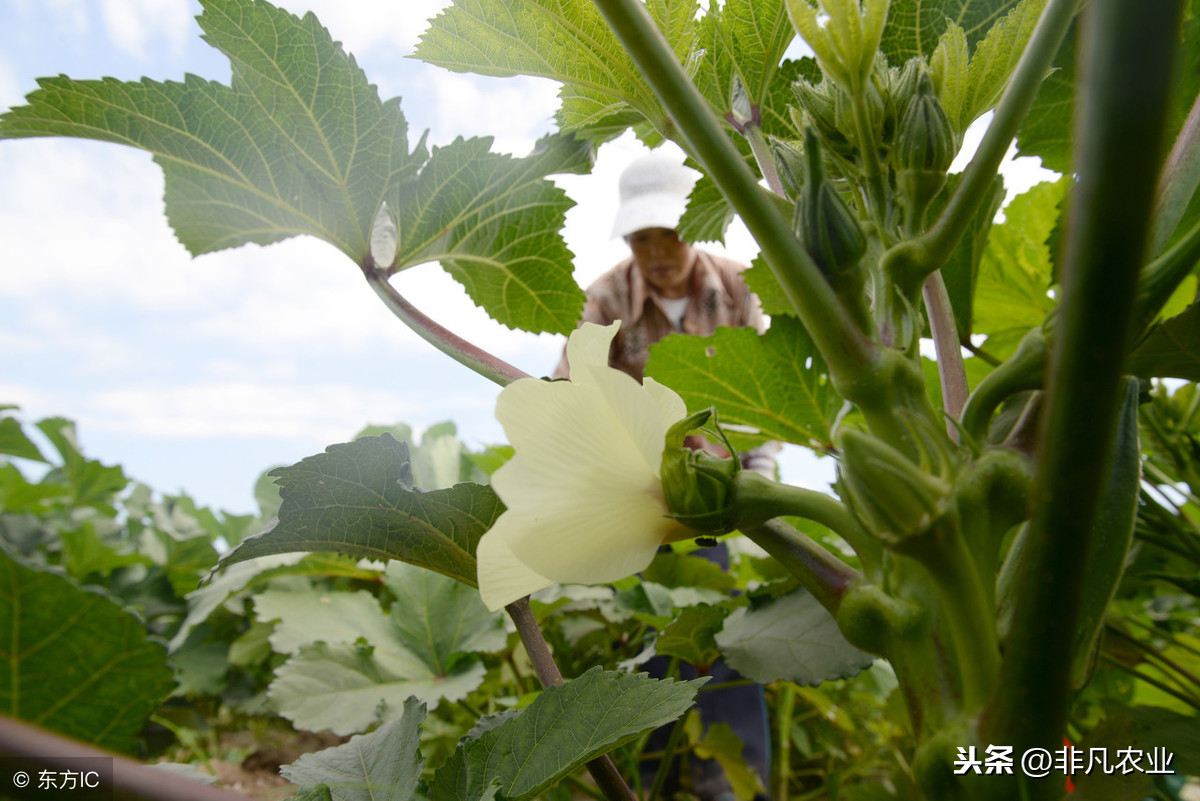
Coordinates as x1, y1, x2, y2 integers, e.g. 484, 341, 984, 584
839, 428, 950, 546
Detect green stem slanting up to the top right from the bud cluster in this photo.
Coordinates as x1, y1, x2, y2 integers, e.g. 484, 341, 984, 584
884, 0, 1079, 295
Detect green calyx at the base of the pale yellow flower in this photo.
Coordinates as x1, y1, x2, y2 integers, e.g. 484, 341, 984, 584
660, 409, 742, 535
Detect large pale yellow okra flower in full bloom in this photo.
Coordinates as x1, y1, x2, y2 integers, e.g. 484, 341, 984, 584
476, 323, 695, 609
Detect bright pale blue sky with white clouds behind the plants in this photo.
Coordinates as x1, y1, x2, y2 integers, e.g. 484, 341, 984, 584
0, 0, 1051, 513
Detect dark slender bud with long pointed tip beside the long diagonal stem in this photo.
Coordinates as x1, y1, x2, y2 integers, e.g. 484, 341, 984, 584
794, 128, 866, 277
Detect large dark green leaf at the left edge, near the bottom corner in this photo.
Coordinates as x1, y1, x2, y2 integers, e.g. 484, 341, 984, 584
0, 549, 174, 753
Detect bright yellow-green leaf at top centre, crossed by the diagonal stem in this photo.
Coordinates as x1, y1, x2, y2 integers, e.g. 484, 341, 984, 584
415, 0, 695, 130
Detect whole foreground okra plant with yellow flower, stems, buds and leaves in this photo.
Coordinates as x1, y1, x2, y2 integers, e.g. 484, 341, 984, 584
0, 0, 1200, 800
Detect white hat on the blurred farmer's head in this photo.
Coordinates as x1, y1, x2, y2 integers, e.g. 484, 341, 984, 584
612, 151, 700, 239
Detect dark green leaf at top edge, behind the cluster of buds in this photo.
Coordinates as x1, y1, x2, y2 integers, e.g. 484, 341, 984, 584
880, 0, 1018, 66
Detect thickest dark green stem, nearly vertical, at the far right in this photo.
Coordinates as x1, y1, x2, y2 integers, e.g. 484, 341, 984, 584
982, 0, 1182, 777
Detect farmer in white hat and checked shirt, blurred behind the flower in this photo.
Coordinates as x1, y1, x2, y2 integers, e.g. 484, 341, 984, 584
554, 151, 779, 801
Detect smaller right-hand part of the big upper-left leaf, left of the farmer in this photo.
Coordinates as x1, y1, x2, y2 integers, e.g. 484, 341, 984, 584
398, 135, 593, 333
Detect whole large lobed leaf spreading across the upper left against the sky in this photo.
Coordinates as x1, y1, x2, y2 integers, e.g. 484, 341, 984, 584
0, 0, 592, 333
